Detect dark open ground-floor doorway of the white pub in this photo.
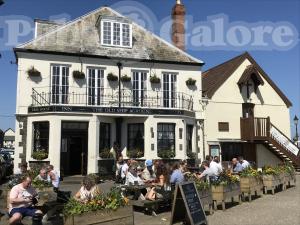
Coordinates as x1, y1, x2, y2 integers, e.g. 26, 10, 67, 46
60, 122, 88, 176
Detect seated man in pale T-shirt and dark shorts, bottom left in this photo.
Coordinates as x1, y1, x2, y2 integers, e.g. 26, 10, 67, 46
9, 175, 42, 225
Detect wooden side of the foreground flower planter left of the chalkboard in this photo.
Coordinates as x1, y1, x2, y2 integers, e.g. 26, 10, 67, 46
64, 206, 134, 225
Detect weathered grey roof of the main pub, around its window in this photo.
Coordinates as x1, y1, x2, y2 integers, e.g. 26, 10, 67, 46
14, 7, 204, 65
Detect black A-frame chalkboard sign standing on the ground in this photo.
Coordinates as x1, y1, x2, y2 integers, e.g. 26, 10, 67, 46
170, 182, 207, 225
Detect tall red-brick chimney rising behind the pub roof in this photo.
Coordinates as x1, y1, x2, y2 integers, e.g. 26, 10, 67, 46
172, 0, 185, 51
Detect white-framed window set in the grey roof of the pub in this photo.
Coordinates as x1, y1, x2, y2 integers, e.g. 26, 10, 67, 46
101, 20, 132, 48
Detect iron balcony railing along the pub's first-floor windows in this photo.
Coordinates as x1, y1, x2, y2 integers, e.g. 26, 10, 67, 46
31, 86, 193, 111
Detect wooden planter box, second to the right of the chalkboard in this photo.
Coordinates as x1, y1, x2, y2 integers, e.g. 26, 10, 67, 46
211, 183, 241, 210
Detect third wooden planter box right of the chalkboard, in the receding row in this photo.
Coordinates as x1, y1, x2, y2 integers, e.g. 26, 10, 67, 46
240, 177, 264, 202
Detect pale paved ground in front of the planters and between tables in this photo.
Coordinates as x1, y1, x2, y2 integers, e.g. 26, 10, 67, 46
0, 175, 300, 225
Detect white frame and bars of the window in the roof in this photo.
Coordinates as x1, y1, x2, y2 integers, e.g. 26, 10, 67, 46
100, 20, 132, 48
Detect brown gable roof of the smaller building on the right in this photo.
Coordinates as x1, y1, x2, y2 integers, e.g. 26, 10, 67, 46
202, 52, 292, 107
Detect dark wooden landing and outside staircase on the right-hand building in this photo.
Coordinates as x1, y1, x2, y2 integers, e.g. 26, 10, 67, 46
241, 117, 300, 171
